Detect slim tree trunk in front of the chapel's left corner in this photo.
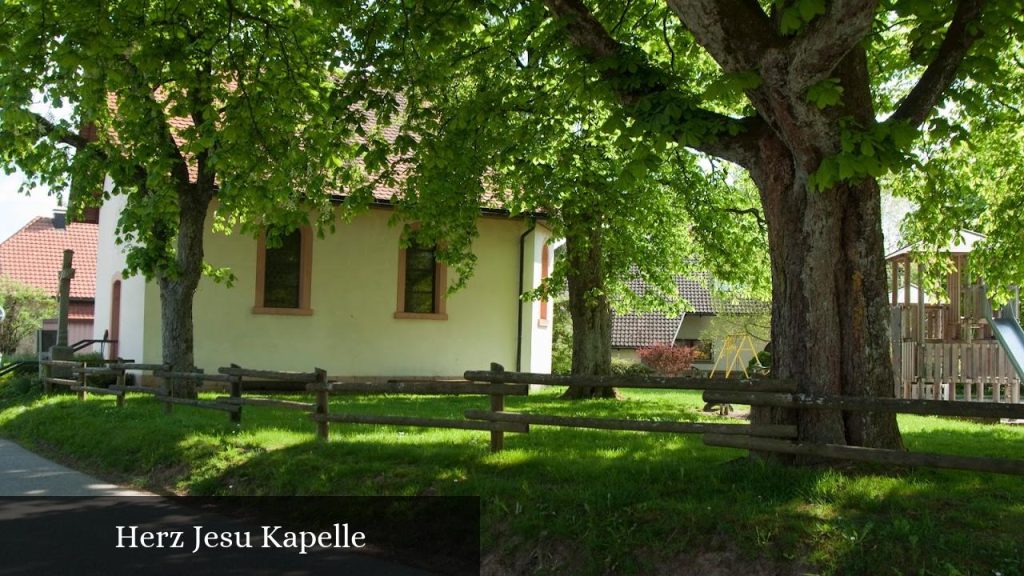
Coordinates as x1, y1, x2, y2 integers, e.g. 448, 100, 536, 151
159, 193, 210, 398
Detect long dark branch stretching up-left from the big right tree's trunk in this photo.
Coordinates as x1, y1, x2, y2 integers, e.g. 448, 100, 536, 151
544, 0, 761, 167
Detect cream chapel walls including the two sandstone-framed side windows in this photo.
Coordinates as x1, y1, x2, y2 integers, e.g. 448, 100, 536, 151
93, 191, 553, 378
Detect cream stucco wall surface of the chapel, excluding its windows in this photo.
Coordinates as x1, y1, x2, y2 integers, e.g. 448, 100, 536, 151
104, 206, 551, 377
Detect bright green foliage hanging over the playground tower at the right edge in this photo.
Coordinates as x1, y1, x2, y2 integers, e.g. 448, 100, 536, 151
891, 54, 1024, 301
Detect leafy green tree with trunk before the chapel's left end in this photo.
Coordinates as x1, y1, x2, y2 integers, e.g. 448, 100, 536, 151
0, 0, 372, 385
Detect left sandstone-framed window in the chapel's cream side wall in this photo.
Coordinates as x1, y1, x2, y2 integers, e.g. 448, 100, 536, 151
253, 228, 312, 316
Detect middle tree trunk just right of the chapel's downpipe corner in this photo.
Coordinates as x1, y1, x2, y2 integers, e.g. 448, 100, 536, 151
562, 227, 617, 399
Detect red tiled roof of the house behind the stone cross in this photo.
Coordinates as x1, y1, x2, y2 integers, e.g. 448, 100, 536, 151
0, 216, 99, 300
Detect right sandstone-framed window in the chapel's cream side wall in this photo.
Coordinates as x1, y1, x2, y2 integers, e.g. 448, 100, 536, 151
394, 240, 447, 320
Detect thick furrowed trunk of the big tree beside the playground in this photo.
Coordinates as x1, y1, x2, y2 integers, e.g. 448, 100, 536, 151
751, 50, 902, 449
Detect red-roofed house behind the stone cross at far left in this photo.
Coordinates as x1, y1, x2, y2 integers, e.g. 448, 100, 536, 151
0, 210, 102, 353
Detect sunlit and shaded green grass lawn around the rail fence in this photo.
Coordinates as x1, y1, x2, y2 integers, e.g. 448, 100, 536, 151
0, 377, 1024, 576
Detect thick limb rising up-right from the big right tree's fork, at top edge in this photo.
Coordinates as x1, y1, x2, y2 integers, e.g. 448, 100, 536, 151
787, 0, 878, 93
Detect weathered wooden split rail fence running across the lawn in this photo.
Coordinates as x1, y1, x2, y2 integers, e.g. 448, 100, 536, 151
44, 361, 1024, 475
